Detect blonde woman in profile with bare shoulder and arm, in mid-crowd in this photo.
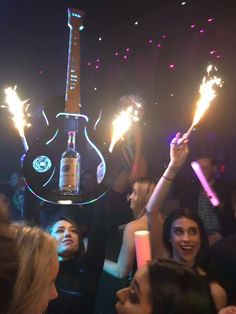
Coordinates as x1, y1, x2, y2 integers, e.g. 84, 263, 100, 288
103, 178, 156, 278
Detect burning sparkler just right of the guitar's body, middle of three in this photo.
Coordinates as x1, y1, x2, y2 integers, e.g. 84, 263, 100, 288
109, 96, 143, 153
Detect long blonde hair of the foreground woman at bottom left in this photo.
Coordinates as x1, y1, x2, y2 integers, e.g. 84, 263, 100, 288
8, 224, 57, 314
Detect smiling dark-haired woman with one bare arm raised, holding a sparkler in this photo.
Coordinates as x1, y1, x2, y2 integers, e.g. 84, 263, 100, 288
147, 133, 227, 310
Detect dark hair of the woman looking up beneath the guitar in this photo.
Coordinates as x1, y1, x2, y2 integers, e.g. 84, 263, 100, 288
47, 214, 85, 263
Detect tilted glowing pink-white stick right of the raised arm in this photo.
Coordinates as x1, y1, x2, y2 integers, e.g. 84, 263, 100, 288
191, 161, 220, 207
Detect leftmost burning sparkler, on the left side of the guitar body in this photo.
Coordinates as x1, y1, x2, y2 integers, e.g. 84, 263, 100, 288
3, 87, 30, 151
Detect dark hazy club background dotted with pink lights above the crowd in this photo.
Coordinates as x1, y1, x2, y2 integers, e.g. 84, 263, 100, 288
0, 0, 236, 181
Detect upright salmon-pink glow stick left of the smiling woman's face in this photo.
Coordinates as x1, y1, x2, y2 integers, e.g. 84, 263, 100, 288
134, 230, 151, 269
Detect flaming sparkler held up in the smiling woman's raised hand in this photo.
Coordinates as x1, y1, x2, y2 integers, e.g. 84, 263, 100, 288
184, 65, 223, 138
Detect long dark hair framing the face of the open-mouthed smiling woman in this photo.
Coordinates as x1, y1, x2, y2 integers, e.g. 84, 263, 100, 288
163, 208, 209, 267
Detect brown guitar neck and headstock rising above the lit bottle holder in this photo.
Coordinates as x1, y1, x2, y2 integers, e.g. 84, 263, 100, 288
65, 9, 82, 113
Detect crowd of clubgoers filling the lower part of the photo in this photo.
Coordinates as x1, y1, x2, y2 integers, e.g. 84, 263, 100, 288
0, 98, 236, 314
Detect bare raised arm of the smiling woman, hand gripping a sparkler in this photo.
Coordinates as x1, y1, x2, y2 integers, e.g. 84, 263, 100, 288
146, 133, 189, 258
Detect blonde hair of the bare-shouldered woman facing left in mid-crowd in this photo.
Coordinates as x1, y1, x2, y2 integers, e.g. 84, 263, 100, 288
134, 178, 156, 218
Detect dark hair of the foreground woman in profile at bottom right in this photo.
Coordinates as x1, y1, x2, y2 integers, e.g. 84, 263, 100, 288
148, 260, 217, 314
